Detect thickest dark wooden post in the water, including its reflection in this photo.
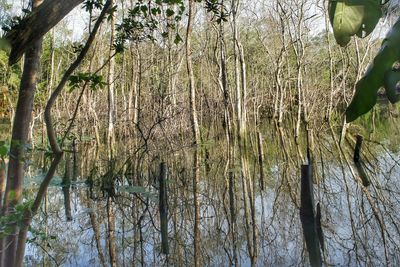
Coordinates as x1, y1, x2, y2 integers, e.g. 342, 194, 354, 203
300, 165, 322, 267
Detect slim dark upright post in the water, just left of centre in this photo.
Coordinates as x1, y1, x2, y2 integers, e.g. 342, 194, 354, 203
158, 162, 169, 255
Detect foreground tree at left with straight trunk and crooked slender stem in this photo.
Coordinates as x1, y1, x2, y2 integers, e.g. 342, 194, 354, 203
0, 0, 111, 267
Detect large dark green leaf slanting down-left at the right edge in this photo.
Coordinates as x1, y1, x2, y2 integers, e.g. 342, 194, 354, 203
346, 19, 400, 122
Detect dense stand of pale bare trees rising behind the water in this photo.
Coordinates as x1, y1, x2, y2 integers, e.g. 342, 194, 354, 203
0, 0, 396, 266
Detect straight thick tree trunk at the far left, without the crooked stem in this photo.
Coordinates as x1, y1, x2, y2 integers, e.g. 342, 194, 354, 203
0, 0, 42, 266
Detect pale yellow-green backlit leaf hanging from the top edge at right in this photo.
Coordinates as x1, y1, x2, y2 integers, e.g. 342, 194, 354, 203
329, 0, 382, 46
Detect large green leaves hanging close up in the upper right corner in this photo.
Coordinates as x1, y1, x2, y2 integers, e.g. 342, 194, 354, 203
329, 0, 400, 122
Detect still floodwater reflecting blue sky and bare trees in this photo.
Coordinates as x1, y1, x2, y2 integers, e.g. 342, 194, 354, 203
2, 120, 400, 266
